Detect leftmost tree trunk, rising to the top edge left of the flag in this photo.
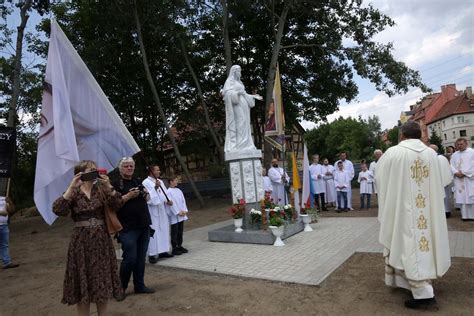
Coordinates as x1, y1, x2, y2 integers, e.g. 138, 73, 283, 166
7, 0, 32, 127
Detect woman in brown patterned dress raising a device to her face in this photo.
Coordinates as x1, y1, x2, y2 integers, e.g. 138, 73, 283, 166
53, 160, 124, 315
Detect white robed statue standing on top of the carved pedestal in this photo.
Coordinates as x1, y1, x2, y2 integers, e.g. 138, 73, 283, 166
221, 65, 263, 152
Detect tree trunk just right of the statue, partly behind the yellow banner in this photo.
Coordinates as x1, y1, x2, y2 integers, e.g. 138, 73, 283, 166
263, 1, 290, 166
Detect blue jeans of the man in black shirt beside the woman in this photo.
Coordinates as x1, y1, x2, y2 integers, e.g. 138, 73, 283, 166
119, 227, 150, 291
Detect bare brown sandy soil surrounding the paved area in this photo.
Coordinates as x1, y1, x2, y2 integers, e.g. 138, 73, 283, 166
0, 191, 474, 315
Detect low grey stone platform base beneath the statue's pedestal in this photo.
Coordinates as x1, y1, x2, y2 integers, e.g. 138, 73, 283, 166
207, 222, 304, 245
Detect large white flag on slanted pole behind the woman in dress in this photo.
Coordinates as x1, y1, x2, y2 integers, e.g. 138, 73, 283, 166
34, 20, 140, 225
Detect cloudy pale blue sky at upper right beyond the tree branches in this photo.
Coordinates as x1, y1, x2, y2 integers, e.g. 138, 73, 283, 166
303, 0, 474, 129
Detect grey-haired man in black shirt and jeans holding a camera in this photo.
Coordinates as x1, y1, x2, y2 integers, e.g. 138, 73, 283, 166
113, 157, 155, 294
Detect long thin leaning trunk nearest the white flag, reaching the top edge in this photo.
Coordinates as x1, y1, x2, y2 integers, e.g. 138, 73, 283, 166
134, 1, 204, 207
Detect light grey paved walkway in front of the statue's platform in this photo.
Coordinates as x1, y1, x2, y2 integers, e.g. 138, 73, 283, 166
158, 217, 474, 285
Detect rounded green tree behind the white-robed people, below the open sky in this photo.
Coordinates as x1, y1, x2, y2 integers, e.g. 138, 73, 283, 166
305, 116, 383, 163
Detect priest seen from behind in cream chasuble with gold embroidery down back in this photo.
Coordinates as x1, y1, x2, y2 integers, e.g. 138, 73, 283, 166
375, 121, 451, 308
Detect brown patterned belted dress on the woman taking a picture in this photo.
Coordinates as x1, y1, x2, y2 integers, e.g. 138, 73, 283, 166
53, 185, 123, 305
